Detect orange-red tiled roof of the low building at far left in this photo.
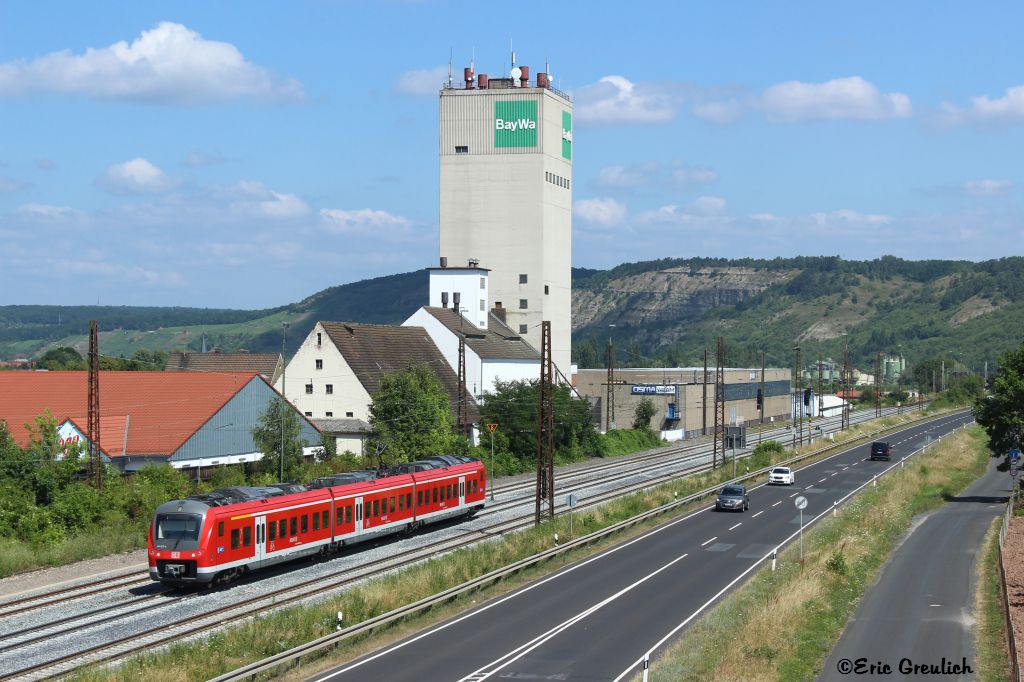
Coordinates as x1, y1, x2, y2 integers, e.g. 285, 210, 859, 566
0, 372, 256, 455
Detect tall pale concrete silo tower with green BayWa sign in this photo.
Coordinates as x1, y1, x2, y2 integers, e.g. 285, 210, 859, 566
430, 62, 572, 376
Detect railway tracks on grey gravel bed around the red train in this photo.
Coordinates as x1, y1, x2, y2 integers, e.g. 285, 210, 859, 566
0, 403, 917, 680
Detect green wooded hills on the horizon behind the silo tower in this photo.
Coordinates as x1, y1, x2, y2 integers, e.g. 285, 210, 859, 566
0, 256, 1024, 372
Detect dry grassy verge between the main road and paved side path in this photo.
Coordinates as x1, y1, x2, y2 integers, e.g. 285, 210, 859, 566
635, 421, 989, 682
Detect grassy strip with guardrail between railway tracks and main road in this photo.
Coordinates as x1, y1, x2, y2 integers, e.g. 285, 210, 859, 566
70, 405, 937, 681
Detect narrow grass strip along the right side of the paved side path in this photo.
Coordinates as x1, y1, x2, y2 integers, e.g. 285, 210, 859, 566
974, 518, 1010, 682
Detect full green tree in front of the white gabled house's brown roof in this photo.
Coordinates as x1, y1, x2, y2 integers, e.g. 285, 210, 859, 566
370, 365, 468, 464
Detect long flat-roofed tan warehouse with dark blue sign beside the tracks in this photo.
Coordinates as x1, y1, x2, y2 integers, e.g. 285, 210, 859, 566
577, 368, 793, 440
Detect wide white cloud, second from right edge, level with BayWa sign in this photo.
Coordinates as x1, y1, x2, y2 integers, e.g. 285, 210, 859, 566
756, 76, 911, 122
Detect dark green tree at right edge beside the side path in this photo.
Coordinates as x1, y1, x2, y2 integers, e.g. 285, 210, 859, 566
974, 343, 1024, 454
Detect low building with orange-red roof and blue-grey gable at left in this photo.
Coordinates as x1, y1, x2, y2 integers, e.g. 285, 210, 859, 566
0, 372, 321, 472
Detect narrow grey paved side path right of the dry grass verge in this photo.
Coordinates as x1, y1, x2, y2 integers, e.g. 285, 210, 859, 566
818, 459, 1011, 681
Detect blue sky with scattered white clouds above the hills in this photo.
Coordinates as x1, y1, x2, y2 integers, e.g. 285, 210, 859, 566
0, 0, 1024, 308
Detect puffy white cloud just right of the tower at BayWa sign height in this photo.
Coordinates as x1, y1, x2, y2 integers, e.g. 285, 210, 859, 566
573, 76, 680, 124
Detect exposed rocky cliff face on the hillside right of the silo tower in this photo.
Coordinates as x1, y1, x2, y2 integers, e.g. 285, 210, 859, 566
572, 267, 798, 331
